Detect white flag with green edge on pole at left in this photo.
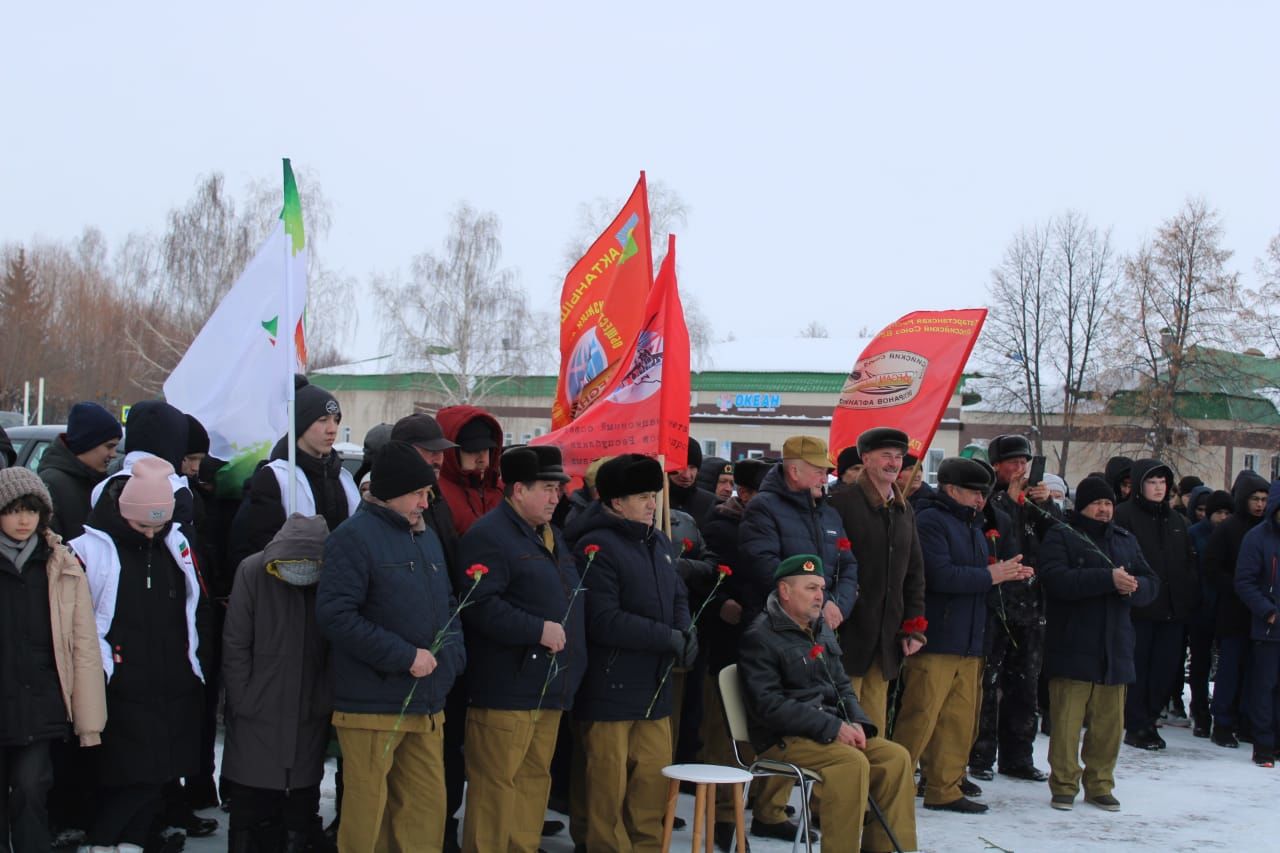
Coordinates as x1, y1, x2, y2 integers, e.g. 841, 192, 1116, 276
164, 159, 307, 494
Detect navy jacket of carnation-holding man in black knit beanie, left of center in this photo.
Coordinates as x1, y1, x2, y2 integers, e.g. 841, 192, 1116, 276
316, 502, 466, 713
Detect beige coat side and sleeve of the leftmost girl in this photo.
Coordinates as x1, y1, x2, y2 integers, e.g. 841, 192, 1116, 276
45, 530, 106, 747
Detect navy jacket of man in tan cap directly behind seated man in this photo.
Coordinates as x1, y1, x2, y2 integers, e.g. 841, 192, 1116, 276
737, 465, 858, 624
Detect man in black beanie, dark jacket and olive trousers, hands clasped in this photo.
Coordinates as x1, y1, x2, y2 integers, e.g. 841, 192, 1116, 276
1039, 476, 1160, 811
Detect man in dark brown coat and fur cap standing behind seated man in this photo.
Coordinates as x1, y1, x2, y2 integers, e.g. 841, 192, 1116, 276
831, 427, 924, 733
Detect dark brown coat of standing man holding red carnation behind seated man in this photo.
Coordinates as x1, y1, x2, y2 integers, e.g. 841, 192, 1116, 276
831, 473, 924, 679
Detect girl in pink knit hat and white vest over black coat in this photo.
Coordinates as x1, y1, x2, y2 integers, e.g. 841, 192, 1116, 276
72, 456, 205, 853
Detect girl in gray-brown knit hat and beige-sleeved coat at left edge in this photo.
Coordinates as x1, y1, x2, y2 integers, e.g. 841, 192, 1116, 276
0, 467, 106, 850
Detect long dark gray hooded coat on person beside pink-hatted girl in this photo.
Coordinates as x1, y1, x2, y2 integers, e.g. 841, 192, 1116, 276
223, 515, 333, 790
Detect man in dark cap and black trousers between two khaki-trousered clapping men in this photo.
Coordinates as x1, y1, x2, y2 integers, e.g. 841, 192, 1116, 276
969, 434, 1061, 781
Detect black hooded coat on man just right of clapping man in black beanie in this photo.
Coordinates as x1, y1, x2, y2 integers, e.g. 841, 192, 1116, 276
1115, 460, 1201, 622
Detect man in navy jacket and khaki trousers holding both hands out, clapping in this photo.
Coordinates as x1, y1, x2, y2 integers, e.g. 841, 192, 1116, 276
893, 457, 1032, 813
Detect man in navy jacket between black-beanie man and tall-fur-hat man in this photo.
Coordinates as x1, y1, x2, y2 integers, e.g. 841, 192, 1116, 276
458, 447, 586, 853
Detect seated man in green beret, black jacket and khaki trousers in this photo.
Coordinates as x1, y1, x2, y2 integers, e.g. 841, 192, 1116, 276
739, 555, 916, 853
